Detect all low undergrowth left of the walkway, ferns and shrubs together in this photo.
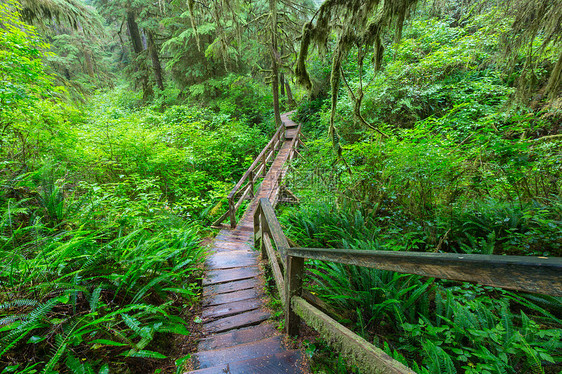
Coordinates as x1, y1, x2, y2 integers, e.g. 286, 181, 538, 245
0, 76, 266, 373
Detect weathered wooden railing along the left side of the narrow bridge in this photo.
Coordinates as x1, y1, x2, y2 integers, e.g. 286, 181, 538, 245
213, 125, 286, 228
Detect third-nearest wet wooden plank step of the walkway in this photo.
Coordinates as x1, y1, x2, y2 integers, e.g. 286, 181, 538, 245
197, 323, 278, 352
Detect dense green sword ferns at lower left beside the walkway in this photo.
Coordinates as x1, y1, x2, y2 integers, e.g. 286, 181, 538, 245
0, 167, 201, 373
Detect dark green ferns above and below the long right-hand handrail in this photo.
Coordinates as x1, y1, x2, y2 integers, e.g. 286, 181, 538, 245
284, 206, 562, 374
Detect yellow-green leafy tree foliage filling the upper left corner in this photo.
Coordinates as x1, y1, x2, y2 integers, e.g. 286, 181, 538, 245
0, 1, 79, 174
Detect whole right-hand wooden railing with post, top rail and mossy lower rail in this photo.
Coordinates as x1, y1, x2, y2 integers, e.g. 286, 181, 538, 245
254, 199, 562, 374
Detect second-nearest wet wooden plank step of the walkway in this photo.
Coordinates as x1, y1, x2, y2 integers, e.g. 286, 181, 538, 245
192, 336, 285, 369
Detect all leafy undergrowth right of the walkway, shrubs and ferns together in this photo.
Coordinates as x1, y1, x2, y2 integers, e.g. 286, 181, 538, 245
280, 7, 562, 374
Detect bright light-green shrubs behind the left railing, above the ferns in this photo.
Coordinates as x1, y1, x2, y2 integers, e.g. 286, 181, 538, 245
72, 87, 266, 219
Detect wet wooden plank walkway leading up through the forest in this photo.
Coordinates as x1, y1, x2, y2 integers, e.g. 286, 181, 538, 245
185, 113, 308, 374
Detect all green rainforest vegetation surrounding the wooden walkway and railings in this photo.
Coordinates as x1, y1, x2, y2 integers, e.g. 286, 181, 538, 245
0, 0, 562, 374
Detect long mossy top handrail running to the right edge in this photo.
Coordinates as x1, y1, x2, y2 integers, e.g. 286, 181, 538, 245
287, 248, 562, 296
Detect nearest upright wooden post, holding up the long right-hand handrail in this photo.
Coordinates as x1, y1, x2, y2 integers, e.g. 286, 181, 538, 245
285, 256, 304, 336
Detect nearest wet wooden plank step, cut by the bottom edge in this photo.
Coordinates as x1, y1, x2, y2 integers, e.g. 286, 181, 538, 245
189, 350, 307, 374
